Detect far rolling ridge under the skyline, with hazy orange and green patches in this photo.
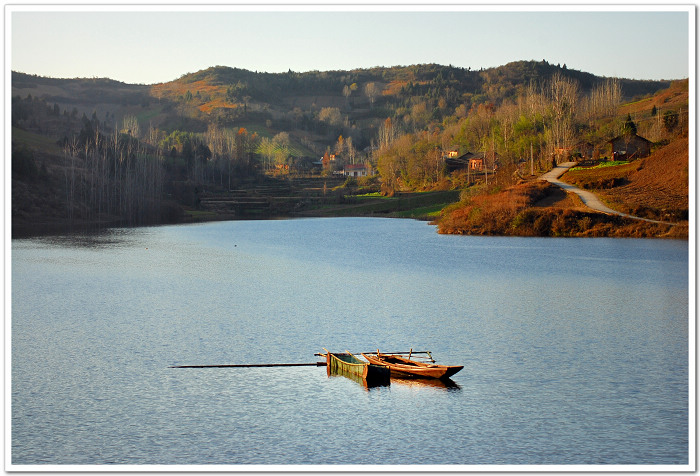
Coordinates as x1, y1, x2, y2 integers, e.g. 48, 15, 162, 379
12, 61, 671, 155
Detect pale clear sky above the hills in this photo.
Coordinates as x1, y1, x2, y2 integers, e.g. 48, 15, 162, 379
5, 5, 695, 84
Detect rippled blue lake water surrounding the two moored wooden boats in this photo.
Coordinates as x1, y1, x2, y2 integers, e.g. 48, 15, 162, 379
8, 218, 692, 470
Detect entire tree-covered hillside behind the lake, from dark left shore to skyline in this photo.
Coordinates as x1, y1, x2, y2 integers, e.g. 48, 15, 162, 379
12, 61, 688, 235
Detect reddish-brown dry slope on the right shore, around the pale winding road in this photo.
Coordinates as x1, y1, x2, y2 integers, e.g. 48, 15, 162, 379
436, 133, 689, 239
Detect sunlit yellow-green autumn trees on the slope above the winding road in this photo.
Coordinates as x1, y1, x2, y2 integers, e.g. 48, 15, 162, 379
375, 73, 676, 192
